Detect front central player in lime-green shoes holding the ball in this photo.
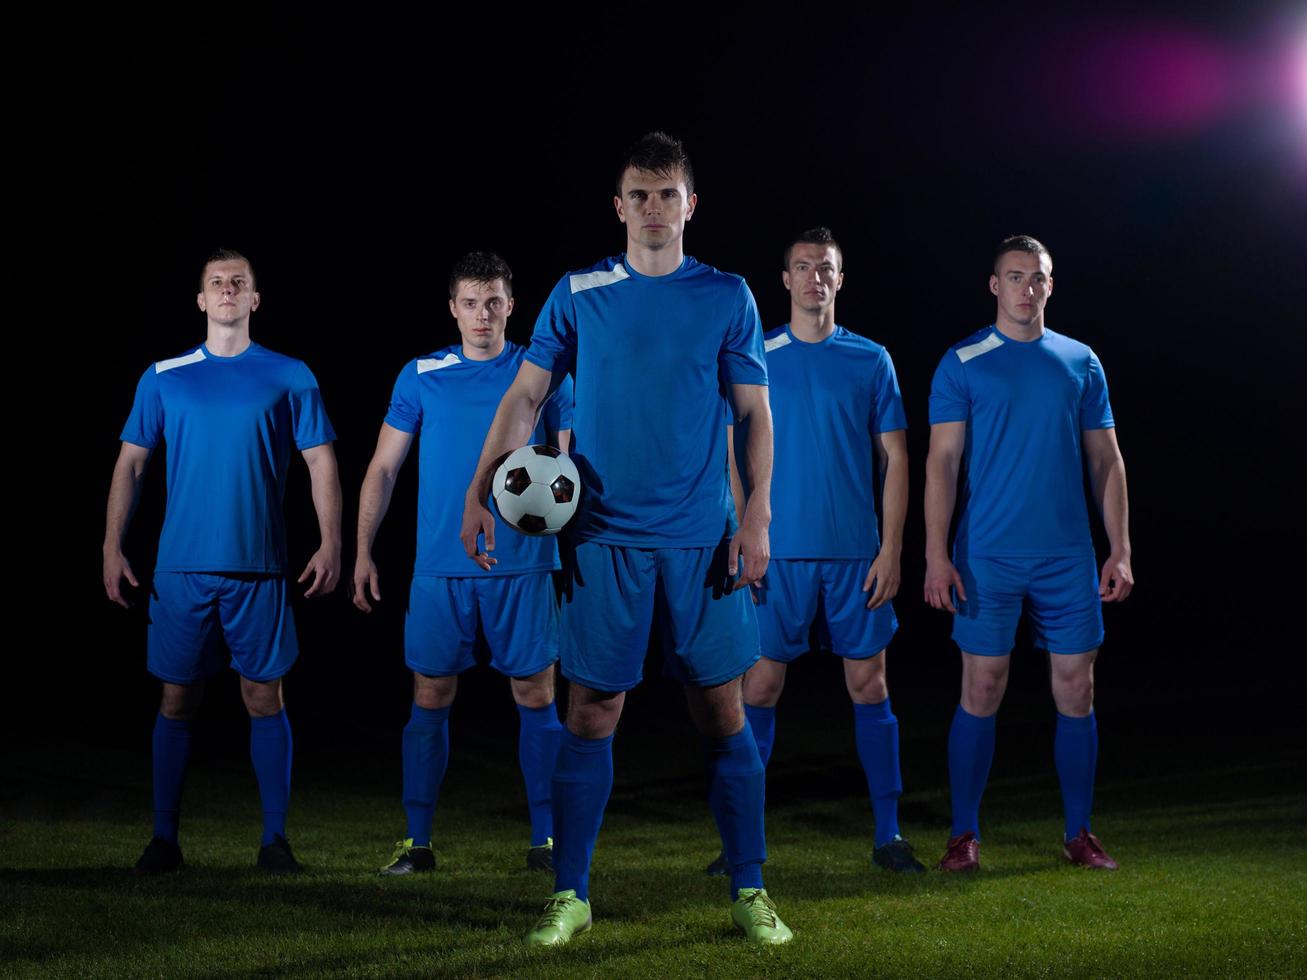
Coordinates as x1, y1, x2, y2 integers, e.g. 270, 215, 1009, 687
463, 133, 791, 945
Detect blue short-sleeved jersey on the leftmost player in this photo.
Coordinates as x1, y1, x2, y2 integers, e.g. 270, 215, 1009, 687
122, 344, 336, 574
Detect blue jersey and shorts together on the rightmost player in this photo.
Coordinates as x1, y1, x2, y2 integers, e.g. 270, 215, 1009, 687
931, 327, 1115, 656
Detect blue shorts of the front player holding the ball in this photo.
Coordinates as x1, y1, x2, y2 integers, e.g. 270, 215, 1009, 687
559, 540, 758, 691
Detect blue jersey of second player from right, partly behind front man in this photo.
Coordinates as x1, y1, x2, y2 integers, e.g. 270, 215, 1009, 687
765, 324, 907, 558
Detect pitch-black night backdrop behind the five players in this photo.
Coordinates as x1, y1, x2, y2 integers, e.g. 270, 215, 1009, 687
20, 5, 1307, 759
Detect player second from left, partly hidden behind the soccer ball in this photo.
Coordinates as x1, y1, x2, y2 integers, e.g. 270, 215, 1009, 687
353, 252, 571, 874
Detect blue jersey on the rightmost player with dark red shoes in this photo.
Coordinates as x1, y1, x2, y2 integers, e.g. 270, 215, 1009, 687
931, 325, 1115, 558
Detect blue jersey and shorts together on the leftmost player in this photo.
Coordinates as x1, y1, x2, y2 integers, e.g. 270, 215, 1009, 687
122, 344, 336, 683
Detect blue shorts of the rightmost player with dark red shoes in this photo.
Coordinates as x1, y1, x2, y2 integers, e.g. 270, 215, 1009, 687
953, 555, 1103, 657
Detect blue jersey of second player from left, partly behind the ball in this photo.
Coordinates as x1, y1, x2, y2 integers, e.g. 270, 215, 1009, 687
386, 341, 572, 578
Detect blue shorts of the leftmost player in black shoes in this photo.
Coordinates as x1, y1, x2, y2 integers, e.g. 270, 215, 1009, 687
146, 572, 299, 683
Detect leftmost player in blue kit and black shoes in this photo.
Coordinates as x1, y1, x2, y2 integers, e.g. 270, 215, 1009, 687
103, 250, 341, 874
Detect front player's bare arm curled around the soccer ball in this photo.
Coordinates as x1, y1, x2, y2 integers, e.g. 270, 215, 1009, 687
459, 361, 562, 571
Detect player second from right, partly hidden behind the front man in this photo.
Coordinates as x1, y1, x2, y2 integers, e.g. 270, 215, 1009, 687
707, 227, 925, 874
